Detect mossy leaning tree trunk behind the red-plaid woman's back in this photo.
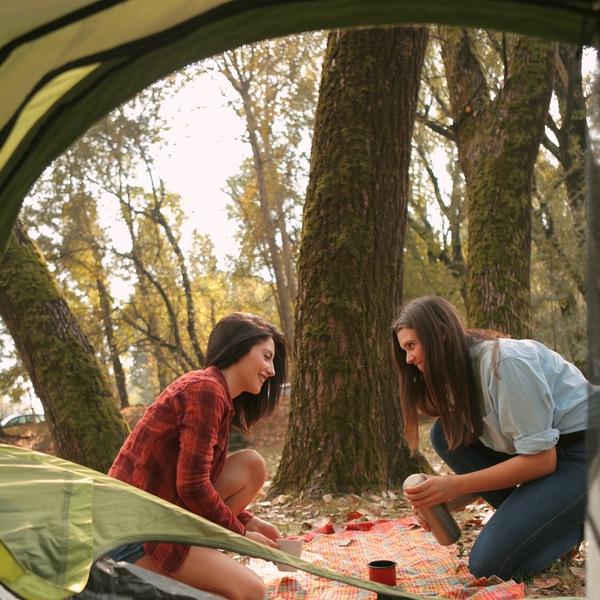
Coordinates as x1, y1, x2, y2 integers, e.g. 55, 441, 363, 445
0, 222, 129, 472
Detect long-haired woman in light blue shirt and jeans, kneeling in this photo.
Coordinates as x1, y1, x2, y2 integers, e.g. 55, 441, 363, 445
392, 296, 592, 579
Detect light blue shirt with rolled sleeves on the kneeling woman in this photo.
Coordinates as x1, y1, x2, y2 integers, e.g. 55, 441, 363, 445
471, 338, 592, 454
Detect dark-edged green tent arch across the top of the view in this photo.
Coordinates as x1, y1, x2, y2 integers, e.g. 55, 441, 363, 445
0, 0, 600, 255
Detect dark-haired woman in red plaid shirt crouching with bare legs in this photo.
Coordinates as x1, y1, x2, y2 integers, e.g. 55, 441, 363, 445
109, 313, 286, 600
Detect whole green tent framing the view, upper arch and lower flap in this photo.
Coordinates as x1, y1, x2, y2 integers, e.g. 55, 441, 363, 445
0, 0, 600, 600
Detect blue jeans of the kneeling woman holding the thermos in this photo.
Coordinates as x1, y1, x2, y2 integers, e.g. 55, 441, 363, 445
430, 420, 587, 580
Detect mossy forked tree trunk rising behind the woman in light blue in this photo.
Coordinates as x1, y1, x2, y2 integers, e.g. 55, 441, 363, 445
440, 28, 554, 337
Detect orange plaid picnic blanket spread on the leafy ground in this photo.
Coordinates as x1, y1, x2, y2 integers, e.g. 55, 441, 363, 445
248, 517, 525, 600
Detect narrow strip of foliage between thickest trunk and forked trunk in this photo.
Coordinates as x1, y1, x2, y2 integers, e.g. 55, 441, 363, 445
403, 37, 467, 305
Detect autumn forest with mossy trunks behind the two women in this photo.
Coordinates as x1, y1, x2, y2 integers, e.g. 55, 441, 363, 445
0, 27, 594, 596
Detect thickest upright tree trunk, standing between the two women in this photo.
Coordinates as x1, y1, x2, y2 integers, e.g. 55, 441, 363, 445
272, 28, 428, 495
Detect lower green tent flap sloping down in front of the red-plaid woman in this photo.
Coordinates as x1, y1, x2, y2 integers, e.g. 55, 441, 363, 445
0, 444, 418, 600
